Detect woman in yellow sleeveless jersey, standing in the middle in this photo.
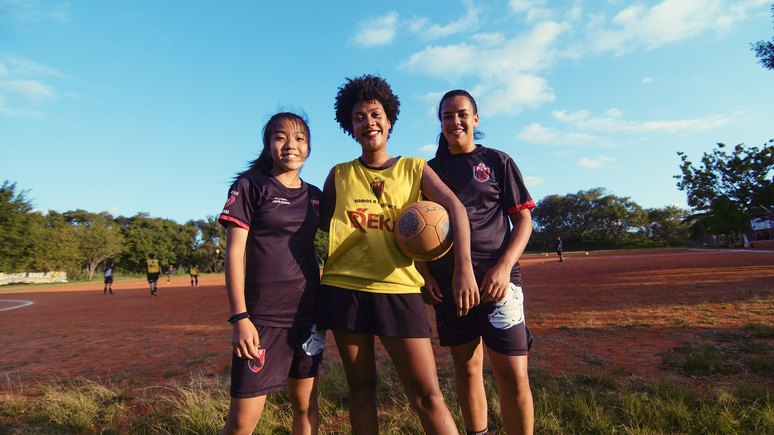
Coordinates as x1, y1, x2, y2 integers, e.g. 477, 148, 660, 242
318, 75, 479, 435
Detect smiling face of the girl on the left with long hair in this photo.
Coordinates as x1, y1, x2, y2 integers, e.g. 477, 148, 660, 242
269, 119, 309, 176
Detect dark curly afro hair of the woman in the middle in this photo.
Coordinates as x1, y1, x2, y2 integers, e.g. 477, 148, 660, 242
333, 74, 400, 139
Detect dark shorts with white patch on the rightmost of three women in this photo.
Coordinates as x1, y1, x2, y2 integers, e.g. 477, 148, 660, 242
434, 284, 533, 355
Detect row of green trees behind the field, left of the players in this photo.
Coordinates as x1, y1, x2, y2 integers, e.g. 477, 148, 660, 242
0, 181, 226, 279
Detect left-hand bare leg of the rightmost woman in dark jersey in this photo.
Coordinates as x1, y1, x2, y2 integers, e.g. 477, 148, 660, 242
449, 338, 489, 432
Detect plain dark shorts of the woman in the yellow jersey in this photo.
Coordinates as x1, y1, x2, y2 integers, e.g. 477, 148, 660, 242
317, 285, 433, 338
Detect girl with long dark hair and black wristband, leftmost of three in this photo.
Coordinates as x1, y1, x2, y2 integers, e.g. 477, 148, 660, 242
218, 113, 325, 435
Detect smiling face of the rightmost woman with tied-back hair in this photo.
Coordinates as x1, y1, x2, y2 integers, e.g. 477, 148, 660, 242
440, 95, 478, 154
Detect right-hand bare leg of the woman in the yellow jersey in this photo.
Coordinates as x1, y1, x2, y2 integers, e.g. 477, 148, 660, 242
379, 337, 457, 435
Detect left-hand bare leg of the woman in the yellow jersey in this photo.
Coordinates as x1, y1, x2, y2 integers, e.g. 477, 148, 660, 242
333, 331, 379, 435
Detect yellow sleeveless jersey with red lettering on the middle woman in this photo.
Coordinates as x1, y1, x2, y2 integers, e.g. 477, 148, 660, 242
322, 157, 425, 294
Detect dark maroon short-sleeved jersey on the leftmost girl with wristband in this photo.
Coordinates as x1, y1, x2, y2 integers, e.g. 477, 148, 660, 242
218, 174, 323, 328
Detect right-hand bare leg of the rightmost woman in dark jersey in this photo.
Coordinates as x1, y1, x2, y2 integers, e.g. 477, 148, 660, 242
489, 349, 535, 435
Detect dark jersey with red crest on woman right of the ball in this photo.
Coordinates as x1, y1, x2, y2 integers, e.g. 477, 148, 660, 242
427, 145, 535, 286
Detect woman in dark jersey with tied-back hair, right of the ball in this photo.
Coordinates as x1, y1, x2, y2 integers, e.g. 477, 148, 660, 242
417, 90, 535, 435
